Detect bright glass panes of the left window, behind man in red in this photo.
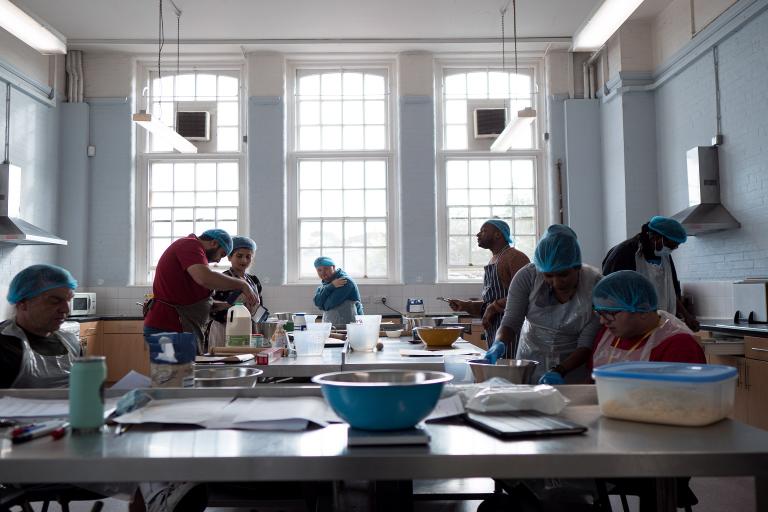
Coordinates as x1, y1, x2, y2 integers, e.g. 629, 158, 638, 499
136, 65, 246, 283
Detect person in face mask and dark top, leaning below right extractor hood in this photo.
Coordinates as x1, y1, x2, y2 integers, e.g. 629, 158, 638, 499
603, 215, 699, 331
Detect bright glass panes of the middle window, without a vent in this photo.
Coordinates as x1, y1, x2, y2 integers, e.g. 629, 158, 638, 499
289, 66, 394, 281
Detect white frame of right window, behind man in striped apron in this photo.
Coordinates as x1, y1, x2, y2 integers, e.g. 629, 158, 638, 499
435, 59, 548, 283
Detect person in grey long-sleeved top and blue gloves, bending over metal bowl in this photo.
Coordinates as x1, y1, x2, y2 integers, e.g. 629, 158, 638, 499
485, 230, 601, 384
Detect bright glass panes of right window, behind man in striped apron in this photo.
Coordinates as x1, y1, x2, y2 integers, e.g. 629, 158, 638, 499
438, 68, 541, 281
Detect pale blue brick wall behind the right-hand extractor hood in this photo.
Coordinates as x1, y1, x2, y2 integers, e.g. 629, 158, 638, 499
656, 0, 768, 280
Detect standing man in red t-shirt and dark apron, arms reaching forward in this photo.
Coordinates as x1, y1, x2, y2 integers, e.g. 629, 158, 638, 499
144, 229, 259, 354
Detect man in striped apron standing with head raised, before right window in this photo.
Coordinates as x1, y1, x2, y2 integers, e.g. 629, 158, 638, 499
448, 219, 530, 347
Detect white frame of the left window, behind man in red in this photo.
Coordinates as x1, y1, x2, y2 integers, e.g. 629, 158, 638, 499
133, 61, 249, 286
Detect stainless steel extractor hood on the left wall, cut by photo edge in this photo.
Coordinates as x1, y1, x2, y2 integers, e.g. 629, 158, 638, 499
0, 163, 67, 245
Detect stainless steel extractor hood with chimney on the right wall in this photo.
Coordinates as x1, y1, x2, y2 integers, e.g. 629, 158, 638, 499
672, 146, 741, 236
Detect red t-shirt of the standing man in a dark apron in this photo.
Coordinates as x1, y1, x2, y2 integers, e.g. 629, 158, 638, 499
144, 235, 211, 332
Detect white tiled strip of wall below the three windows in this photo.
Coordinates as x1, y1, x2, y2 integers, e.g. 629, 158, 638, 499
82, 283, 482, 316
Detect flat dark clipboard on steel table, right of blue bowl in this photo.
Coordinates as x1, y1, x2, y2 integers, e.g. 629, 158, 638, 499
464, 411, 587, 439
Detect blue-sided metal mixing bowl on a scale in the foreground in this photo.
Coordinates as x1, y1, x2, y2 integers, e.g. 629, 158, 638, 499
312, 370, 453, 430
